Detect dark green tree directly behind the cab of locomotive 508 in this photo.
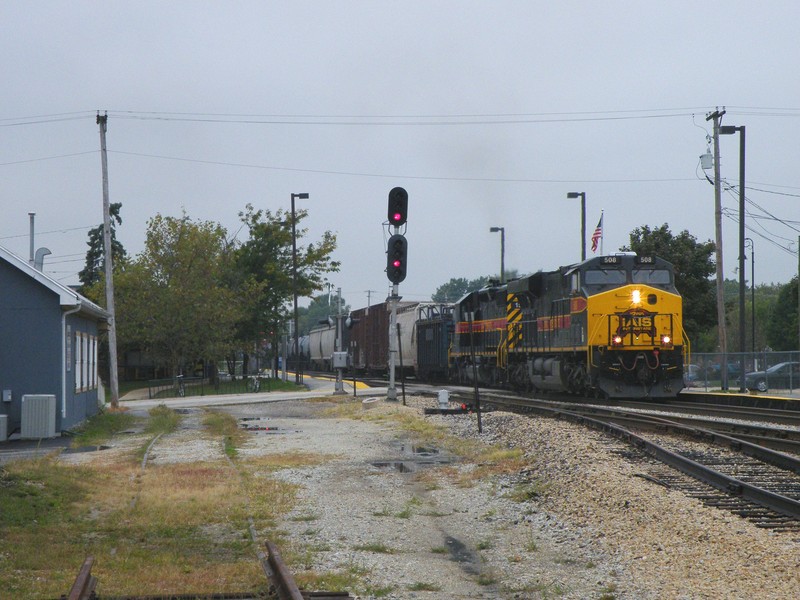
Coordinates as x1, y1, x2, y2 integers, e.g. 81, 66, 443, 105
622, 223, 717, 342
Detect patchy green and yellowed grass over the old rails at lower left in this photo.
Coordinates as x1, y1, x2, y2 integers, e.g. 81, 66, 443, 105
0, 407, 321, 598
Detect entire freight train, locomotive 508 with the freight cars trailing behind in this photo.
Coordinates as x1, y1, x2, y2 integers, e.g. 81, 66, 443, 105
300, 253, 688, 399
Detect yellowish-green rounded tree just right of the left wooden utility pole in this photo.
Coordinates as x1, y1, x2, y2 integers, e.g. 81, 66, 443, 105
115, 213, 246, 372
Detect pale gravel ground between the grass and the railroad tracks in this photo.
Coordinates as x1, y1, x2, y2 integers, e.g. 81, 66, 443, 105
61, 398, 800, 600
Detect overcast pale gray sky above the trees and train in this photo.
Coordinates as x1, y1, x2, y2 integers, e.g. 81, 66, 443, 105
0, 0, 800, 307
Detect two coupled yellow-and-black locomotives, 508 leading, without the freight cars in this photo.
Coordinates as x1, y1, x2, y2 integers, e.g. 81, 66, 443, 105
449, 253, 688, 399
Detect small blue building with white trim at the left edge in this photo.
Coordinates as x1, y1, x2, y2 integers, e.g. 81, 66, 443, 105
0, 247, 110, 436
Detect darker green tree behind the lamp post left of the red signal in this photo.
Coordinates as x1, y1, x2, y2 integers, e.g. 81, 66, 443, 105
231, 204, 339, 342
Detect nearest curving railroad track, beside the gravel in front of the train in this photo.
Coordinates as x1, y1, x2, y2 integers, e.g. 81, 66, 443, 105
456, 393, 800, 532
